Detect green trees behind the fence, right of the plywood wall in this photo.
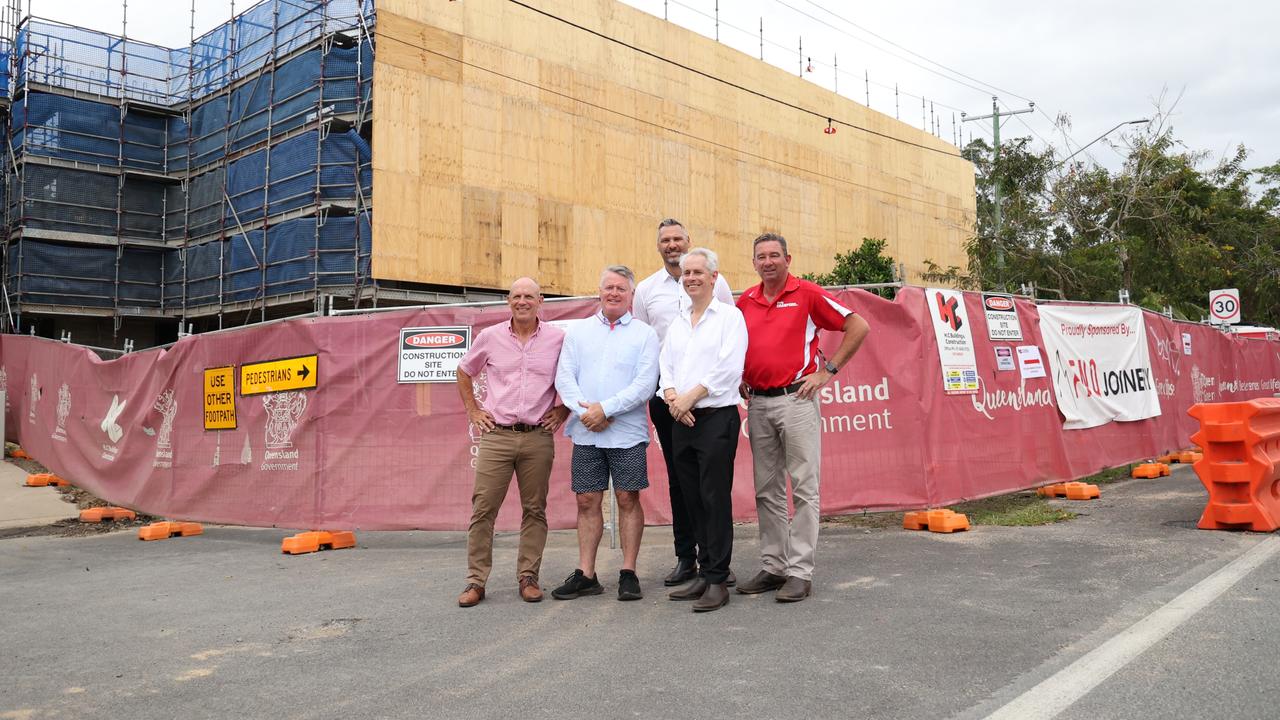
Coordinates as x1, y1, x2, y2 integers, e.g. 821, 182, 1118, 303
962, 123, 1280, 324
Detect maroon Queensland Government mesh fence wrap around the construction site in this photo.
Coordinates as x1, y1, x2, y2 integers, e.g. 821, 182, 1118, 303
0, 287, 1280, 529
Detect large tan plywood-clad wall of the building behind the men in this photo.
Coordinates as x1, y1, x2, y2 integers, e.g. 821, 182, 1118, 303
372, 0, 975, 295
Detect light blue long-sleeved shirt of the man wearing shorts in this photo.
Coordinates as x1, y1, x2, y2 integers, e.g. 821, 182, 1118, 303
556, 311, 659, 447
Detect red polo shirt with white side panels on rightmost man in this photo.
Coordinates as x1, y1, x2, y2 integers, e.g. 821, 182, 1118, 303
737, 274, 852, 389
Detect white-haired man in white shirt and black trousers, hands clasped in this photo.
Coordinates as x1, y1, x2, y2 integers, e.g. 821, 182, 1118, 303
658, 247, 748, 612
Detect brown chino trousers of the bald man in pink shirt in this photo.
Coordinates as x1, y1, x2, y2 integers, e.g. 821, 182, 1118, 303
467, 428, 556, 587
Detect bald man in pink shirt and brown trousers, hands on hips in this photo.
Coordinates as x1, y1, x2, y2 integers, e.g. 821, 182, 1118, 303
458, 278, 568, 607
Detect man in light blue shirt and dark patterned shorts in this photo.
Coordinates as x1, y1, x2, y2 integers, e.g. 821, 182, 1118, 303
552, 265, 659, 600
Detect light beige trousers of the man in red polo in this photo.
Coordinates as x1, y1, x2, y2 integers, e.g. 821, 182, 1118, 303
746, 395, 822, 580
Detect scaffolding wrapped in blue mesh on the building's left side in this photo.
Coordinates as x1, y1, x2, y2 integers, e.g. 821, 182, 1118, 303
0, 0, 375, 331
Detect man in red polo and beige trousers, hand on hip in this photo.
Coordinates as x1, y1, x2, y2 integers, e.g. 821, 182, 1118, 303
737, 233, 870, 602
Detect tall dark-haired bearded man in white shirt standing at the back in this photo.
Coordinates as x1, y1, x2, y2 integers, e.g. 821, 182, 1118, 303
631, 218, 733, 585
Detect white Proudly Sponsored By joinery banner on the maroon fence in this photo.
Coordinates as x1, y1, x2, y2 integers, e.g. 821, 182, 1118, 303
1039, 305, 1160, 430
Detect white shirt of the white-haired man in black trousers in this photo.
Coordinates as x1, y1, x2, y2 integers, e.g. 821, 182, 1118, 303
658, 300, 746, 407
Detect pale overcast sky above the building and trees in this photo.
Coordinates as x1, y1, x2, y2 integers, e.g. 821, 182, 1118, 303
32, 0, 1280, 178
